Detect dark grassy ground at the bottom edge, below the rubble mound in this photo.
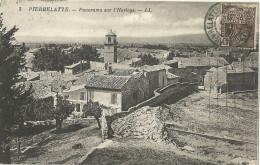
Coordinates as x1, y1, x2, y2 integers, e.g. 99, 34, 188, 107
83, 138, 214, 165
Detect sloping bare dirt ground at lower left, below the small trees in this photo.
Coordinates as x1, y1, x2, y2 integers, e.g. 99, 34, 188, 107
12, 124, 102, 164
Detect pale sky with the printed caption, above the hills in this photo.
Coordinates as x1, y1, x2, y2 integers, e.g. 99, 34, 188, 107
0, 0, 214, 38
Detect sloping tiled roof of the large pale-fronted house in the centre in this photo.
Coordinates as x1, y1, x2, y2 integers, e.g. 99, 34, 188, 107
85, 75, 131, 90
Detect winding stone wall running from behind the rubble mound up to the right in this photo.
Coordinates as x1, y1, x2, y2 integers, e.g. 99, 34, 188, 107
102, 83, 198, 137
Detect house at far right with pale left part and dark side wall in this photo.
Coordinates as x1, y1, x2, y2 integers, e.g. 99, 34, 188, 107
204, 66, 257, 93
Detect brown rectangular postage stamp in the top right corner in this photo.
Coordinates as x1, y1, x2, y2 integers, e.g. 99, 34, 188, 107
220, 3, 257, 49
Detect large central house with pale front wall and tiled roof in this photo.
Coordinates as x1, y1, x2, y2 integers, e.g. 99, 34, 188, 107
85, 75, 149, 112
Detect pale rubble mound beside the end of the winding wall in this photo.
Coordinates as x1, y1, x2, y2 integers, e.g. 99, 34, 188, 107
111, 106, 169, 140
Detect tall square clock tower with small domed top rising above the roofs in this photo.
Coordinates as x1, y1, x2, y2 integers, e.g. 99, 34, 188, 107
104, 29, 117, 63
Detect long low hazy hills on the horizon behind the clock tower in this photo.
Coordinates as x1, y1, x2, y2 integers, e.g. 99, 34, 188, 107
16, 34, 210, 44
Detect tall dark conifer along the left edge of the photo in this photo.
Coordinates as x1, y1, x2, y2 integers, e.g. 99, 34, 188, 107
0, 14, 31, 163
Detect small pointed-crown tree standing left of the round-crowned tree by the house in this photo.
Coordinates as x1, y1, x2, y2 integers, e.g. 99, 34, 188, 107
53, 95, 75, 131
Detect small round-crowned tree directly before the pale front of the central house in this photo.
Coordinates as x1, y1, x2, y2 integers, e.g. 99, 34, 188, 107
82, 100, 105, 129
